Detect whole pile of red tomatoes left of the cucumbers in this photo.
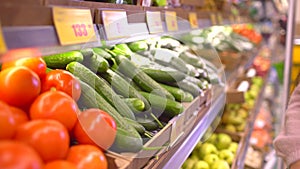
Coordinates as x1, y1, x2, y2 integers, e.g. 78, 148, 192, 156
0, 57, 116, 169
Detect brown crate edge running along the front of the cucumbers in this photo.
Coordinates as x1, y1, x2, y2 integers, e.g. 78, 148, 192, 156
106, 90, 211, 169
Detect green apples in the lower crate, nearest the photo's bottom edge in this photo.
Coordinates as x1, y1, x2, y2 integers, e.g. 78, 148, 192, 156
181, 133, 238, 169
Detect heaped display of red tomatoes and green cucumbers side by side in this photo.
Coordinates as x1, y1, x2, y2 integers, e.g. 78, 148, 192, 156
0, 37, 220, 169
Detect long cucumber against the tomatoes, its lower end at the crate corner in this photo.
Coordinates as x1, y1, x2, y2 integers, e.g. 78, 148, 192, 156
78, 81, 143, 152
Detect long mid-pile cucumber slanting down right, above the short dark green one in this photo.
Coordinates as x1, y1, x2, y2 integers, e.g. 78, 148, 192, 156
115, 55, 175, 100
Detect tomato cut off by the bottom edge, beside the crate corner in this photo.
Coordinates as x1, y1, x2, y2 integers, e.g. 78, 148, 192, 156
67, 145, 107, 169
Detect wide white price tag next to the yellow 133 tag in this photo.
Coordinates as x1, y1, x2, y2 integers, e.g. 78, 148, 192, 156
102, 11, 129, 40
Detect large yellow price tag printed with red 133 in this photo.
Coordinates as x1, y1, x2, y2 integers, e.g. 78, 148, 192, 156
52, 7, 97, 45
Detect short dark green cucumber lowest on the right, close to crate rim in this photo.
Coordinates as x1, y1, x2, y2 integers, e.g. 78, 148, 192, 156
140, 92, 184, 117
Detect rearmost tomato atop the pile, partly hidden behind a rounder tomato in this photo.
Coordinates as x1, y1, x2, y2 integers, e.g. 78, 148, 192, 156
2, 57, 47, 78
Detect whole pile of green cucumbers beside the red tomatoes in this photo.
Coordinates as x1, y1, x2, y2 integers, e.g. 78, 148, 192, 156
43, 37, 216, 152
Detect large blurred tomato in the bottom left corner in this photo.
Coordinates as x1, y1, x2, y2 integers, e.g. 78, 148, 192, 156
0, 140, 43, 169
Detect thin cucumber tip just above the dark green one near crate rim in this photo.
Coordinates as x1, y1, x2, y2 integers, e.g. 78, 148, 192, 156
160, 84, 194, 102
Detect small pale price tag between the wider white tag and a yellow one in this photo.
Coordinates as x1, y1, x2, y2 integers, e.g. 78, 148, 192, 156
146, 11, 164, 34
